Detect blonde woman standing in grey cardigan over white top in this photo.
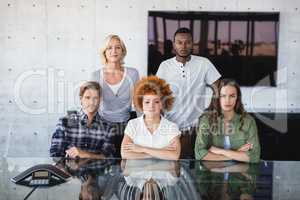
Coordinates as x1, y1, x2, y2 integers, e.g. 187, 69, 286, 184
91, 35, 139, 157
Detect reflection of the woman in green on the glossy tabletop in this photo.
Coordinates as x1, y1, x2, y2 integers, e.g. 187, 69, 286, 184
197, 162, 259, 200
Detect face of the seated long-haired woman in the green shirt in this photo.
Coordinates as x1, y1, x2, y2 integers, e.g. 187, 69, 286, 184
220, 85, 238, 112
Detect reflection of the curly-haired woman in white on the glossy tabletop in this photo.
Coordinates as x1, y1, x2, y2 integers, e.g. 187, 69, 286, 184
120, 160, 198, 200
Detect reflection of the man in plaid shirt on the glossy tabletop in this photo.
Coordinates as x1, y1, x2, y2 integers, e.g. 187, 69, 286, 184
56, 159, 124, 200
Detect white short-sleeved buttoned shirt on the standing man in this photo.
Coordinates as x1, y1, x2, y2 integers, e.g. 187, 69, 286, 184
156, 55, 221, 128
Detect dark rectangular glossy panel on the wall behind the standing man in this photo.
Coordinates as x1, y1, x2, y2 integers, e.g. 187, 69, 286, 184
148, 11, 279, 86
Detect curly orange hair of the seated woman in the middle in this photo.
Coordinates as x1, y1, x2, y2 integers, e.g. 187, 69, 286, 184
133, 76, 174, 112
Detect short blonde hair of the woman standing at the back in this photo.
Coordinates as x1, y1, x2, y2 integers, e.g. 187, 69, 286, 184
100, 34, 127, 65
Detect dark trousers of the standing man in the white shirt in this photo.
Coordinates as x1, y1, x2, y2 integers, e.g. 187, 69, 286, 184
180, 127, 197, 159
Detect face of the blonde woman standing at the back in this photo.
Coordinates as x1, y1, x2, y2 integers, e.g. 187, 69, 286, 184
105, 38, 124, 63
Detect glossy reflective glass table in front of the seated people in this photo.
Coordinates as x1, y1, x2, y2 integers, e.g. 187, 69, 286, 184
0, 157, 300, 200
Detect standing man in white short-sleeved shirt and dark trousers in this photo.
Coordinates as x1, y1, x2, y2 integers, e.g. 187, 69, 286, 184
156, 28, 221, 158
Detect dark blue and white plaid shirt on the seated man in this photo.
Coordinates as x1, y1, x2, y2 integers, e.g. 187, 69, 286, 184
50, 110, 115, 157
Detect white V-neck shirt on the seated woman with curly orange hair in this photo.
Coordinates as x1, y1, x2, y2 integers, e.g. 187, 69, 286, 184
124, 115, 181, 148
